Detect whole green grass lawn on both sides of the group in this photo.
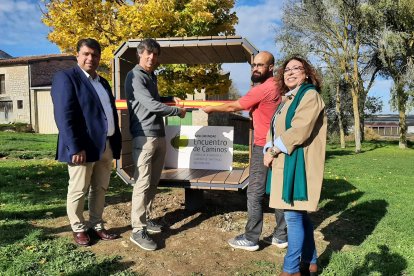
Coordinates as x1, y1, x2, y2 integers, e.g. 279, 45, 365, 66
0, 132, 414, 276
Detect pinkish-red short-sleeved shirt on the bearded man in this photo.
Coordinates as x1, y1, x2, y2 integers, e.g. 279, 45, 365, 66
239, 77, 281, 147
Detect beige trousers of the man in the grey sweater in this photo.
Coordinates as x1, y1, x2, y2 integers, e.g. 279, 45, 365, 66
131, 136, 167, 232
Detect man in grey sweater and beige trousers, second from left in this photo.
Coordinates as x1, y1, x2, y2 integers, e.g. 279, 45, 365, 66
125, 38, 186, 250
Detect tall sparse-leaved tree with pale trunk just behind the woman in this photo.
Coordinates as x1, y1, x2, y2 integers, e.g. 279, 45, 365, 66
277, 0, 376, 152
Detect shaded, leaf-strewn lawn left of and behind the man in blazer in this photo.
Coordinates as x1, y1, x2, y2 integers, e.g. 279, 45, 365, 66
0, 132, 135, 276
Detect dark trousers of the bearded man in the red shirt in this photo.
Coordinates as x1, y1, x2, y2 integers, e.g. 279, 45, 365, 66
244, 145, 287, 243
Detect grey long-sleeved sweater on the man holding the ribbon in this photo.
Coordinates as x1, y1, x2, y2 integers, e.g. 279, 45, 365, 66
125, 65, 180, 137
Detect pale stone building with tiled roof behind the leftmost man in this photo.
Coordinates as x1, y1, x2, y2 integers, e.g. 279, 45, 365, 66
0, 51, 76, 133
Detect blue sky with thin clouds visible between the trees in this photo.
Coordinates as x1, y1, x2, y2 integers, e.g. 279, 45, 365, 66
0, 0, 400, 113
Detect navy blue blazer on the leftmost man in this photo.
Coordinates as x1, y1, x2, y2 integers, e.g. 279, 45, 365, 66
51, 66, 121, 163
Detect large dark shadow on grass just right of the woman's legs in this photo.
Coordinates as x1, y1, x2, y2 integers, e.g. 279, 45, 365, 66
311, 179, 394, 275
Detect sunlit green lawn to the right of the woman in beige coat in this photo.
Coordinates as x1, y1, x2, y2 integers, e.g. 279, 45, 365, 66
315, 142, 414, 276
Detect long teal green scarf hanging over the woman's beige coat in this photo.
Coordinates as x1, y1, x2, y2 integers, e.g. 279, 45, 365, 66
282, 83, 316, 204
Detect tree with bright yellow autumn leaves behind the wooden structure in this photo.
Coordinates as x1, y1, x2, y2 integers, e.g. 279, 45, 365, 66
42, 0, 238, 96
